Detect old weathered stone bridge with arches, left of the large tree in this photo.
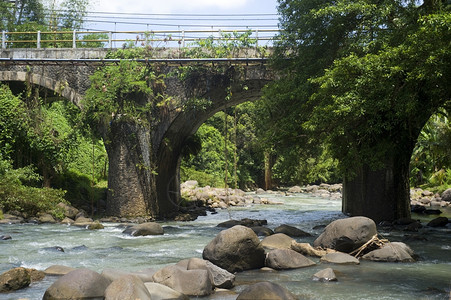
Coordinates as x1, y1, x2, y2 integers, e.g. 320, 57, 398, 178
0, 49, 274, 218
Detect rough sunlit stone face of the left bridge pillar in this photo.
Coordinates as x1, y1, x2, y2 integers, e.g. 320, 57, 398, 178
105, 117, 159, 217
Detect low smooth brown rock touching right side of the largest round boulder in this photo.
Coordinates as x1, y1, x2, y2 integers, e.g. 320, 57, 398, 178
265, 249, 316, 270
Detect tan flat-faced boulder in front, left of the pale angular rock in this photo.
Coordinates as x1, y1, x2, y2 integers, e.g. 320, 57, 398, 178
152, 265, 213, 297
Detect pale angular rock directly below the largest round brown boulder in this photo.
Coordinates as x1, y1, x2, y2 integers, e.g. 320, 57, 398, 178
181, 258, 235, 289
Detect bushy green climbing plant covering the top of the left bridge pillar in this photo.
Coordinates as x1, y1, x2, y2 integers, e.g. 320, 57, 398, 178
82, 48, 161, 135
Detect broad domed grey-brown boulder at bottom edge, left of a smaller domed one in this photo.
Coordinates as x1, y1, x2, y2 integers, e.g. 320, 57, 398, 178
42, 268, 111, 300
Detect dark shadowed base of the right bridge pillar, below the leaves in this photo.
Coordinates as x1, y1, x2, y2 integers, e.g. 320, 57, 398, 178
342, 151, 410, 223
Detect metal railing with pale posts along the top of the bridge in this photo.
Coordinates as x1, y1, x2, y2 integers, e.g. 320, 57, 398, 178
1, 29, 279, 49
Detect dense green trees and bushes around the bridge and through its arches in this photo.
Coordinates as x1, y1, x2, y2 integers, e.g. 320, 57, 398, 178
0, 0, 451, 219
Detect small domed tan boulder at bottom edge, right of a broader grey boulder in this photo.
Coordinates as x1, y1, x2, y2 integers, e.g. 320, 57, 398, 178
105, 275, 151, 300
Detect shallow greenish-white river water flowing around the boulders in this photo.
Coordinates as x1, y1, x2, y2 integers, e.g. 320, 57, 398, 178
0, 195, 451, 300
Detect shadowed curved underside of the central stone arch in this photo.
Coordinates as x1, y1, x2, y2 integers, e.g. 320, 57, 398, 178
155, 66, 273, 216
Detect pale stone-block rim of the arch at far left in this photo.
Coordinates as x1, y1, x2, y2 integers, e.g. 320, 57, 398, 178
0, 71, 82, 107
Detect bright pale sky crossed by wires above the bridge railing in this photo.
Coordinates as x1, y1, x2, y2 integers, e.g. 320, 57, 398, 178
84, 0, 278, 31
